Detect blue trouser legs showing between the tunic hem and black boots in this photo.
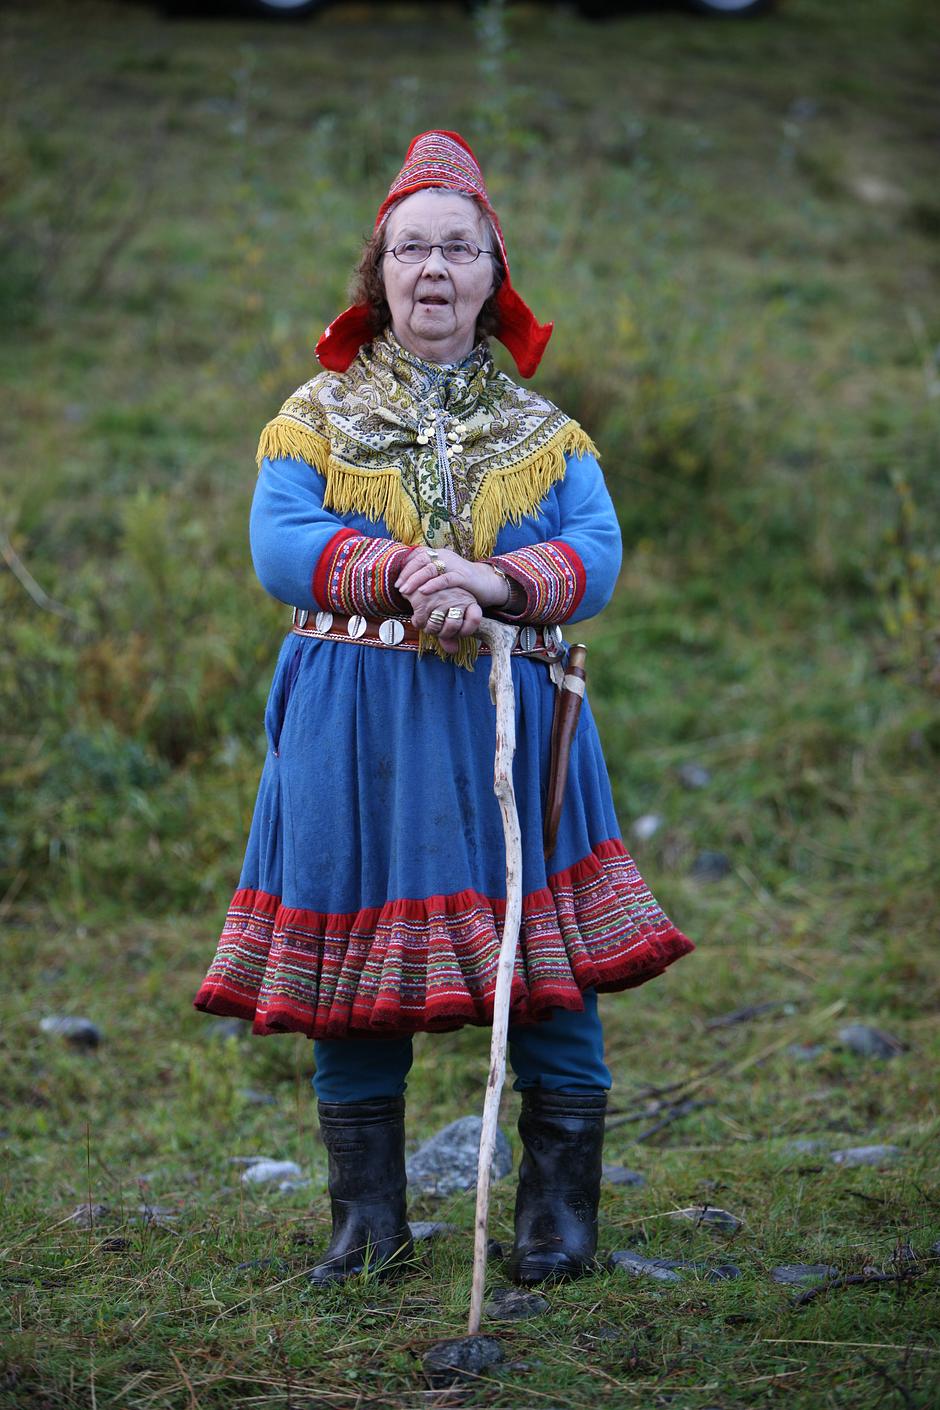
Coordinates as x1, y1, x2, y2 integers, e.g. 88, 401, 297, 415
313, 990, 612, 1103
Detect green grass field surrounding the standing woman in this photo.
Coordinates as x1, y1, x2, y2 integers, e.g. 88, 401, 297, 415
0, 0, 940, 1410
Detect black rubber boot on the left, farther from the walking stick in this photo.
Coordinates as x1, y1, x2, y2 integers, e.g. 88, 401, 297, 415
307, 1097, 414, 1287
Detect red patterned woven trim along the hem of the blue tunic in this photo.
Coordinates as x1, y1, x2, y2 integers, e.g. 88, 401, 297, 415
194, 839, 695, 1038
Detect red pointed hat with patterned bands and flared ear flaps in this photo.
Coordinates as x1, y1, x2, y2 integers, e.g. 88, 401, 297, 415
317, 131, 552, 376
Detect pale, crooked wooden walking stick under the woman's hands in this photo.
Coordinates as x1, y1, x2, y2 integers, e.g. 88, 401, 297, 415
466, 618, 523, 1337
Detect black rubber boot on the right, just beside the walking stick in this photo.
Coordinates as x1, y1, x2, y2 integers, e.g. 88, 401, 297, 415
509, 1087, 607, 1286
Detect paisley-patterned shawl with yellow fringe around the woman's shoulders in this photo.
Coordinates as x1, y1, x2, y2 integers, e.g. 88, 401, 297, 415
258, 333, 598, 664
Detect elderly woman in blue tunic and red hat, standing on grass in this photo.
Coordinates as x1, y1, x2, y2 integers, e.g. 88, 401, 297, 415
196, 131, 692, 1285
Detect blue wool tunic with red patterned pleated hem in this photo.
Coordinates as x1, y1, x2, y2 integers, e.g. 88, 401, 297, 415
196, 454, 692, 1038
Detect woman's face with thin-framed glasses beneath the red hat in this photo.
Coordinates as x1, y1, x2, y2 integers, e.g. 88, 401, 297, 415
382, 189, 495, 362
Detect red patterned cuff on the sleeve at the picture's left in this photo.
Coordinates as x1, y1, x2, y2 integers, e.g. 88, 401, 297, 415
313, 529, 413, 618
